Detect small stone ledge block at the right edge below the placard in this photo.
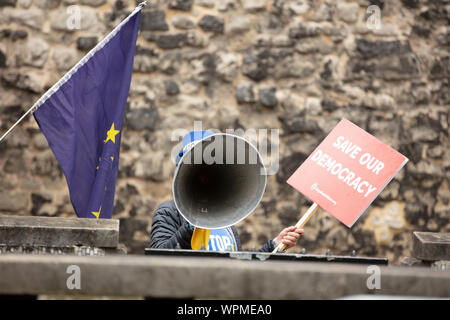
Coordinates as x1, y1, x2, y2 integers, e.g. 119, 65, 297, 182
412, 231, 450, 261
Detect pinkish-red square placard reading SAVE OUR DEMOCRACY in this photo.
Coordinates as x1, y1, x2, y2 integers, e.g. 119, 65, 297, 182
287, 119, 408, 227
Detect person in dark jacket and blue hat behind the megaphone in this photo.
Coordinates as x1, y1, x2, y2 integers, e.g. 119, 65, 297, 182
150, 131, 303, 252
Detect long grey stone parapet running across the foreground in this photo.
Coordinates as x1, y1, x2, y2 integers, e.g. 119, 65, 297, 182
0, 255, 450, 299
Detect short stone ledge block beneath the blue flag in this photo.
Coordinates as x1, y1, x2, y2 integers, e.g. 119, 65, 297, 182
0, 216, 119, 248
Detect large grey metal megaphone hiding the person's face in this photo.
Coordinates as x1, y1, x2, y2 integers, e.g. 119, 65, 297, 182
172, 133, 267, 229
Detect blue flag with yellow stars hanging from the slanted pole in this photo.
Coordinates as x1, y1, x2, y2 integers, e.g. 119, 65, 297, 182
34, 6, 141, 219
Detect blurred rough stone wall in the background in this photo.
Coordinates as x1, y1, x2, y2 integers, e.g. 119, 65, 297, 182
0, 0, 450, 262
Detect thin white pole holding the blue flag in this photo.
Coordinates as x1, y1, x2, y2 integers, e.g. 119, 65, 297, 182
0, 1, 147, 143
